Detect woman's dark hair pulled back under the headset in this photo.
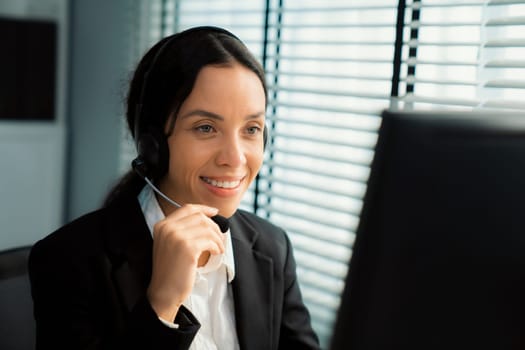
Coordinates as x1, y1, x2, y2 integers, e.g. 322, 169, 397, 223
104, 27, 267, 205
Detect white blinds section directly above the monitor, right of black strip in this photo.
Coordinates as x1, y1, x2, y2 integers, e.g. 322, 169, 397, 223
400, 0, 525, 109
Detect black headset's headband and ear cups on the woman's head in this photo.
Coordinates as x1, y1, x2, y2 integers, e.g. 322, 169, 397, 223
131, 26, 267, 180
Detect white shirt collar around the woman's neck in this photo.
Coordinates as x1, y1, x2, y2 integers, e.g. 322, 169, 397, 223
137, 185, 235, 282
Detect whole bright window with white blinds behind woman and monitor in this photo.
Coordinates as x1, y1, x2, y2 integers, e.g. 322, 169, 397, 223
121, 0, 525, 347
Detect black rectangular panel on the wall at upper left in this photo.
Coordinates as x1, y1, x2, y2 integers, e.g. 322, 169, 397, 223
0, 17, 57, 121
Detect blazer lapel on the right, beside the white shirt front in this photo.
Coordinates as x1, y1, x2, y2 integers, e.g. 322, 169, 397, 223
230, 215, 274, 350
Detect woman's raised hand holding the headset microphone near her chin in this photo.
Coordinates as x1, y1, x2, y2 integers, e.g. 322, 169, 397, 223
147, 204, 224, 321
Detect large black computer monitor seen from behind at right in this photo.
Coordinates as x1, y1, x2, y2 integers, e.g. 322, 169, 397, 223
330, 111, 525, 350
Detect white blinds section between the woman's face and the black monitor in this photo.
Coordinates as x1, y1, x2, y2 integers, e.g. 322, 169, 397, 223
257, 0, 397, 345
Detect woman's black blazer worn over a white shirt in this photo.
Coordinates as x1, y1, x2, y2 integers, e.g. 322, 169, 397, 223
29, 197, 319, 350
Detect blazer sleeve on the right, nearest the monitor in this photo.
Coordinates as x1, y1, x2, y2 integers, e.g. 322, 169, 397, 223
279, 235, 320, 350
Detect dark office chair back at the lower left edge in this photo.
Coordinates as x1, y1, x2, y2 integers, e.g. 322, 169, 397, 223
0, 246, 35, 350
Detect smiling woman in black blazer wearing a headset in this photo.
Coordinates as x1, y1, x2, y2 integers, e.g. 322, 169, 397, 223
29, 27, 318, 350
